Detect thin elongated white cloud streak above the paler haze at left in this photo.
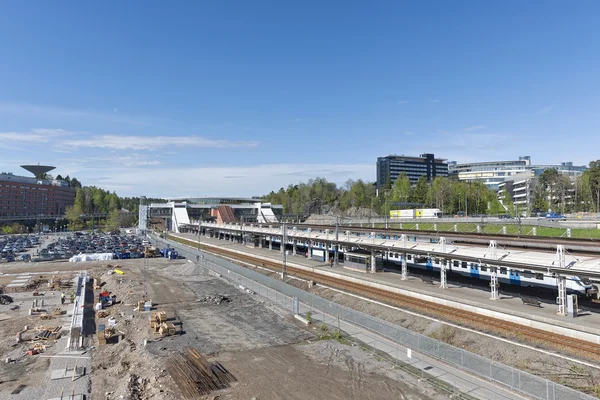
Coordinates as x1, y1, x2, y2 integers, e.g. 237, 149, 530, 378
63, 135, 258, 150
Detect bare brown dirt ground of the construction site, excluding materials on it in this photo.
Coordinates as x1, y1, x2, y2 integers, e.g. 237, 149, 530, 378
0, 258, 445, 400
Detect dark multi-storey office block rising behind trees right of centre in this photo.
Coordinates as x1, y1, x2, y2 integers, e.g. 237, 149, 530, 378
377, 153, 448, 192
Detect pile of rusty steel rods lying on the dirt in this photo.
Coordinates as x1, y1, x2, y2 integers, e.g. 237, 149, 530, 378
167, 347, 236, 399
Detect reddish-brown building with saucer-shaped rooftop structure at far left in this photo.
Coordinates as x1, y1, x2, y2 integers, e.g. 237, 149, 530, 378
0, 165, 75, 217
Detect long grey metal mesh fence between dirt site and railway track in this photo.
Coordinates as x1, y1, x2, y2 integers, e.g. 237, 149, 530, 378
154, 234, 597, 400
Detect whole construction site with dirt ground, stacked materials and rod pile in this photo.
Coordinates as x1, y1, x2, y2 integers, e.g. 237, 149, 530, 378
0, 253, 440, 400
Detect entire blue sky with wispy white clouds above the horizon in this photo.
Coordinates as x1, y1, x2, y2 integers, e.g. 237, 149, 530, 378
0, 1, 600, 197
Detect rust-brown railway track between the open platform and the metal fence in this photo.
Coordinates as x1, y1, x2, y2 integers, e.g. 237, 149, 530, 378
172, 239, 600, 361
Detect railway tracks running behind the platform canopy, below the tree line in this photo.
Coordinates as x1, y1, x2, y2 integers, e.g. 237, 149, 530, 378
274, 224, 600, 253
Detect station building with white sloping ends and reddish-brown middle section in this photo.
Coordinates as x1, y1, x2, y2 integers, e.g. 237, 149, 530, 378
148, 197, 283, 232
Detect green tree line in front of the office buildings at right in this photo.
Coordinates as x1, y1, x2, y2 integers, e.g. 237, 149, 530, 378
263, 160, 600, 215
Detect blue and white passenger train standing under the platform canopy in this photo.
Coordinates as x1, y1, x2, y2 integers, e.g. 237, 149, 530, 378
387, 252, 598, 297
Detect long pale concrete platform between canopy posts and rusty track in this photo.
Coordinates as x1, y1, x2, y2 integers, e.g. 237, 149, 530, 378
177, 233, 600, 343
